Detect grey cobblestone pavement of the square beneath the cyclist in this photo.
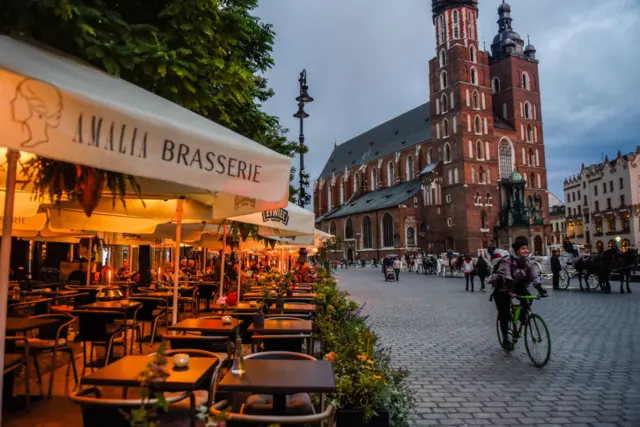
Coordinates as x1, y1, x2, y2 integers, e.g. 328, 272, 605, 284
337, 268, 640, 427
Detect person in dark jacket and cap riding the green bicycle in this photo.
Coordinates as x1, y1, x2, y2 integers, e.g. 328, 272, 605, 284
490, 238, 547, 350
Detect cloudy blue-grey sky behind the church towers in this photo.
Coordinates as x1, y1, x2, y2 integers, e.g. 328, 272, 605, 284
256, 0, 640, 204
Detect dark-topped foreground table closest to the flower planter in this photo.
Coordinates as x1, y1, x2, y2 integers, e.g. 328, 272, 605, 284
218, 359, 336, 414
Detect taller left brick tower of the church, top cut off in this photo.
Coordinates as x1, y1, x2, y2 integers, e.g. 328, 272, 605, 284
425, 0, 499, 252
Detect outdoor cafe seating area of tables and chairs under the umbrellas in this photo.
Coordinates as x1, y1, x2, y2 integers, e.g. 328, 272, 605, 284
3, 267, 336, 427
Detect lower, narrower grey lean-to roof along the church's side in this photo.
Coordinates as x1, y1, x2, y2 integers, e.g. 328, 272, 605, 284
316, 179, 422, 223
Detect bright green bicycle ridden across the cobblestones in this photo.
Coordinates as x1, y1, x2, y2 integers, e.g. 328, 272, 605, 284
496, 295, 551, 368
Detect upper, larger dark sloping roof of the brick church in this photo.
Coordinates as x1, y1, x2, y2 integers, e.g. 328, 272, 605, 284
320, 102, 431, 178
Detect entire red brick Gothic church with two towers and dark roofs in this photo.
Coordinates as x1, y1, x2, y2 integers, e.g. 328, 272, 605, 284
314, 0, 551, 260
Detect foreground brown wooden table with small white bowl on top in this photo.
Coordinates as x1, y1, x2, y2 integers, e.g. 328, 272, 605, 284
81, 356, 218, 391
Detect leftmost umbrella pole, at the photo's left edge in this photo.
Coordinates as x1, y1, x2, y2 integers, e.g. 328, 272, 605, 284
0, 150, 20, 425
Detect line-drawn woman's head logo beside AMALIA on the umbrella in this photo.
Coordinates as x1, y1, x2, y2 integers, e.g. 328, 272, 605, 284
11, 79, 62, 148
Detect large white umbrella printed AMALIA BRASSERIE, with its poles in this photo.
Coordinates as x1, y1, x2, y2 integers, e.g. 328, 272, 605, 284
0, 36, 291, 414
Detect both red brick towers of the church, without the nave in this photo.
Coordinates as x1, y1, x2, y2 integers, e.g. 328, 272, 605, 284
423, 0, 548, 252
